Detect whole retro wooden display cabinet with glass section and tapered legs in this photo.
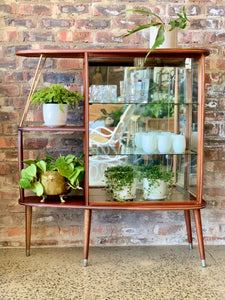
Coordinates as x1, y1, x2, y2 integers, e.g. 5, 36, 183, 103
16, 49, 209, 266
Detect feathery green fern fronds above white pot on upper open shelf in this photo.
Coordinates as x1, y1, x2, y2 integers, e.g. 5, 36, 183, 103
31, 84, 84, 111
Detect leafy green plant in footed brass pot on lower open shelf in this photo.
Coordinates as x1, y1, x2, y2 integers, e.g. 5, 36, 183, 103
19, 154, 85, 202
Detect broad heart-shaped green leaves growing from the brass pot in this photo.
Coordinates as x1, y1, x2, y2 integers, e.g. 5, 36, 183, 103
19, 154, 85, 196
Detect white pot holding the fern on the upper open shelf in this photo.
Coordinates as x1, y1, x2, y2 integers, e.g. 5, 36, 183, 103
43, 103, 68, 127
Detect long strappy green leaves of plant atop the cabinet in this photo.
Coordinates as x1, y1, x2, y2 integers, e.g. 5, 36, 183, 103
121, 7, 189, 59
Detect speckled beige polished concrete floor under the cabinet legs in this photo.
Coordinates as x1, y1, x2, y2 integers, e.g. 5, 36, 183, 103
0, 246, 225, 300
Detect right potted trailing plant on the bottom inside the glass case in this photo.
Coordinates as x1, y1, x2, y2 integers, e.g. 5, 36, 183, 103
138, 165, 174, 200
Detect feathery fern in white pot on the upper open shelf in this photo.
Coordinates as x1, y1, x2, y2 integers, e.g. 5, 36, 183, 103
31, 84, 83, 127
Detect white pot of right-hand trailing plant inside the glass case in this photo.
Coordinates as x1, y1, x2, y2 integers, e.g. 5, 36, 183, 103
143, 178, 169, 200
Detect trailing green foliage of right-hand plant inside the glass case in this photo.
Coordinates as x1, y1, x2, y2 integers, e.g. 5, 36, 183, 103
137, 165, 174, 197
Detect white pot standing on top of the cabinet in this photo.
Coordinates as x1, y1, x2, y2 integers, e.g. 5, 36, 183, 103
149, 26, 178, 49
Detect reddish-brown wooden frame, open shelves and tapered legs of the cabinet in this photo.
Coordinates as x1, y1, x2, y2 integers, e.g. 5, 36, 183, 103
16, 49, 209, 266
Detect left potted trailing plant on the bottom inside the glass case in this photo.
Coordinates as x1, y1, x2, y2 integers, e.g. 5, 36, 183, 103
105, 165, 136, 202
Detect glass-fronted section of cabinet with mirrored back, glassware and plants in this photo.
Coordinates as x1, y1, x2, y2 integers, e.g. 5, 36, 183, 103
89, 55, 199, 203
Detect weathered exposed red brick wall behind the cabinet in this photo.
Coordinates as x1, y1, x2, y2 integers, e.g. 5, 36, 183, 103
0, 0, 225, 246
